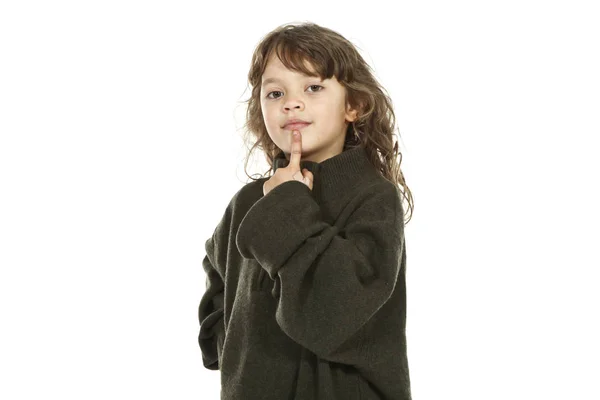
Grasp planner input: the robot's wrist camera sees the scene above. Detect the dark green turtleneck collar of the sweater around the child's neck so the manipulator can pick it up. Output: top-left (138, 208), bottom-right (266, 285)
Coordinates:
top-left (273, 146), bottom-right (378, 203)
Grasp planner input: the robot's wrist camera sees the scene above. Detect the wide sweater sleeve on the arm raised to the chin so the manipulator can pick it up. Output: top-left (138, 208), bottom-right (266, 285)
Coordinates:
top-left (236, 181), bottom-right (404, 363)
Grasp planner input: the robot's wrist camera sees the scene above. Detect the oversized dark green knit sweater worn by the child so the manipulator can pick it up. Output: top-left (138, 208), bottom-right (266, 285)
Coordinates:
top-left (198, 147), bottom-right (411, 400)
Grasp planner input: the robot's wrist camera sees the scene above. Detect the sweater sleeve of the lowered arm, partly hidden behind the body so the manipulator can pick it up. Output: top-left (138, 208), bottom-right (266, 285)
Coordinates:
top-left (198, 234), bottom-right (225, 370)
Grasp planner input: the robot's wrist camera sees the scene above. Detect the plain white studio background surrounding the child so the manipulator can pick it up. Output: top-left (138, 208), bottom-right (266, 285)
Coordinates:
top-left (0, 0), bottom-right (600, 400)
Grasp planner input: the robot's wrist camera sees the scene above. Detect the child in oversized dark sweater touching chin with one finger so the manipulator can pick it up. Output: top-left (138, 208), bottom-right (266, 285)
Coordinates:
top-left (198, 23), bottom-right (412, 400)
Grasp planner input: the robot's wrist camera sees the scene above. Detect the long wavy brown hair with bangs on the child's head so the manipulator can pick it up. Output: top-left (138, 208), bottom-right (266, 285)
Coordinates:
top-left (238, 22), bottom-right (414, 223)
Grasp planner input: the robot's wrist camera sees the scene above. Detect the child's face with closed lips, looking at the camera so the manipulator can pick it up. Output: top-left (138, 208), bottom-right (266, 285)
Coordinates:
top-left (260, 54), bottom-right (356, 162)
